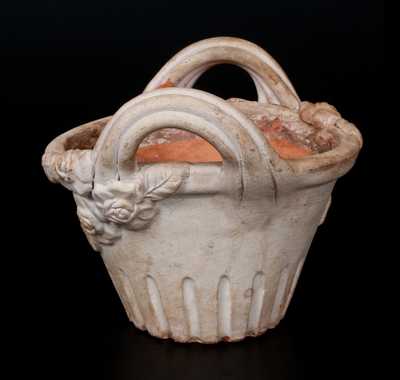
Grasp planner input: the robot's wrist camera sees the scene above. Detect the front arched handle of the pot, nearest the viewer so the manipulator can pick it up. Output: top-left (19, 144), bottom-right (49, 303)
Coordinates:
top-left (95, 88), bottom-right (285, 198)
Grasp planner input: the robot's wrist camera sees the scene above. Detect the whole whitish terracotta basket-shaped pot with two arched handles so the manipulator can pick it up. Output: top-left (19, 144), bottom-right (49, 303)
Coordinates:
top-left (43, 38), bottom-right (362, 343)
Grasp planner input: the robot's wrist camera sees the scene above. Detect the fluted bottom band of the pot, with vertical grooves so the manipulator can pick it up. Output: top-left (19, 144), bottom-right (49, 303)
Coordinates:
top-left (103, 257), bottom-right (304, 343)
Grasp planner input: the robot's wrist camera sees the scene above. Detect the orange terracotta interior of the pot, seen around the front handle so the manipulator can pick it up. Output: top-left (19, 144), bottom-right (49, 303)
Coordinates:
top-left (65, 99), bottom-right (337, 163)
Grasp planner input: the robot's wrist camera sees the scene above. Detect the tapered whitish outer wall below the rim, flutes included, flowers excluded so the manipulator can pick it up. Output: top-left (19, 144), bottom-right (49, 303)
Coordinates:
top-left (98, 189), bottom-right (329, 343)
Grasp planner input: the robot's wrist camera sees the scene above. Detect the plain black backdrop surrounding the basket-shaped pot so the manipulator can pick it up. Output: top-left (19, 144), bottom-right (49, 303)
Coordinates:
top-left (0, 0), bottom-right (385, 380)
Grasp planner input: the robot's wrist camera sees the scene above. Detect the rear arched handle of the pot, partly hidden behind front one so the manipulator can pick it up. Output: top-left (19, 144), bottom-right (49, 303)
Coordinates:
top-left (145, 37), bottom-right (300, 111)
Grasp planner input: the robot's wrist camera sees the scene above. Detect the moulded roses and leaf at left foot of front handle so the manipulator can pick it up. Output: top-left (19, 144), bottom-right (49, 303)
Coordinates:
top-left (60, 164), bottom-right (188, 251)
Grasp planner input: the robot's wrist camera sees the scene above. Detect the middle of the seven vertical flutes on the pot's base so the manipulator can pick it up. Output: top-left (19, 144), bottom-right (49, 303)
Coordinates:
top-left (218, 276), bottom-right (232, 340)
